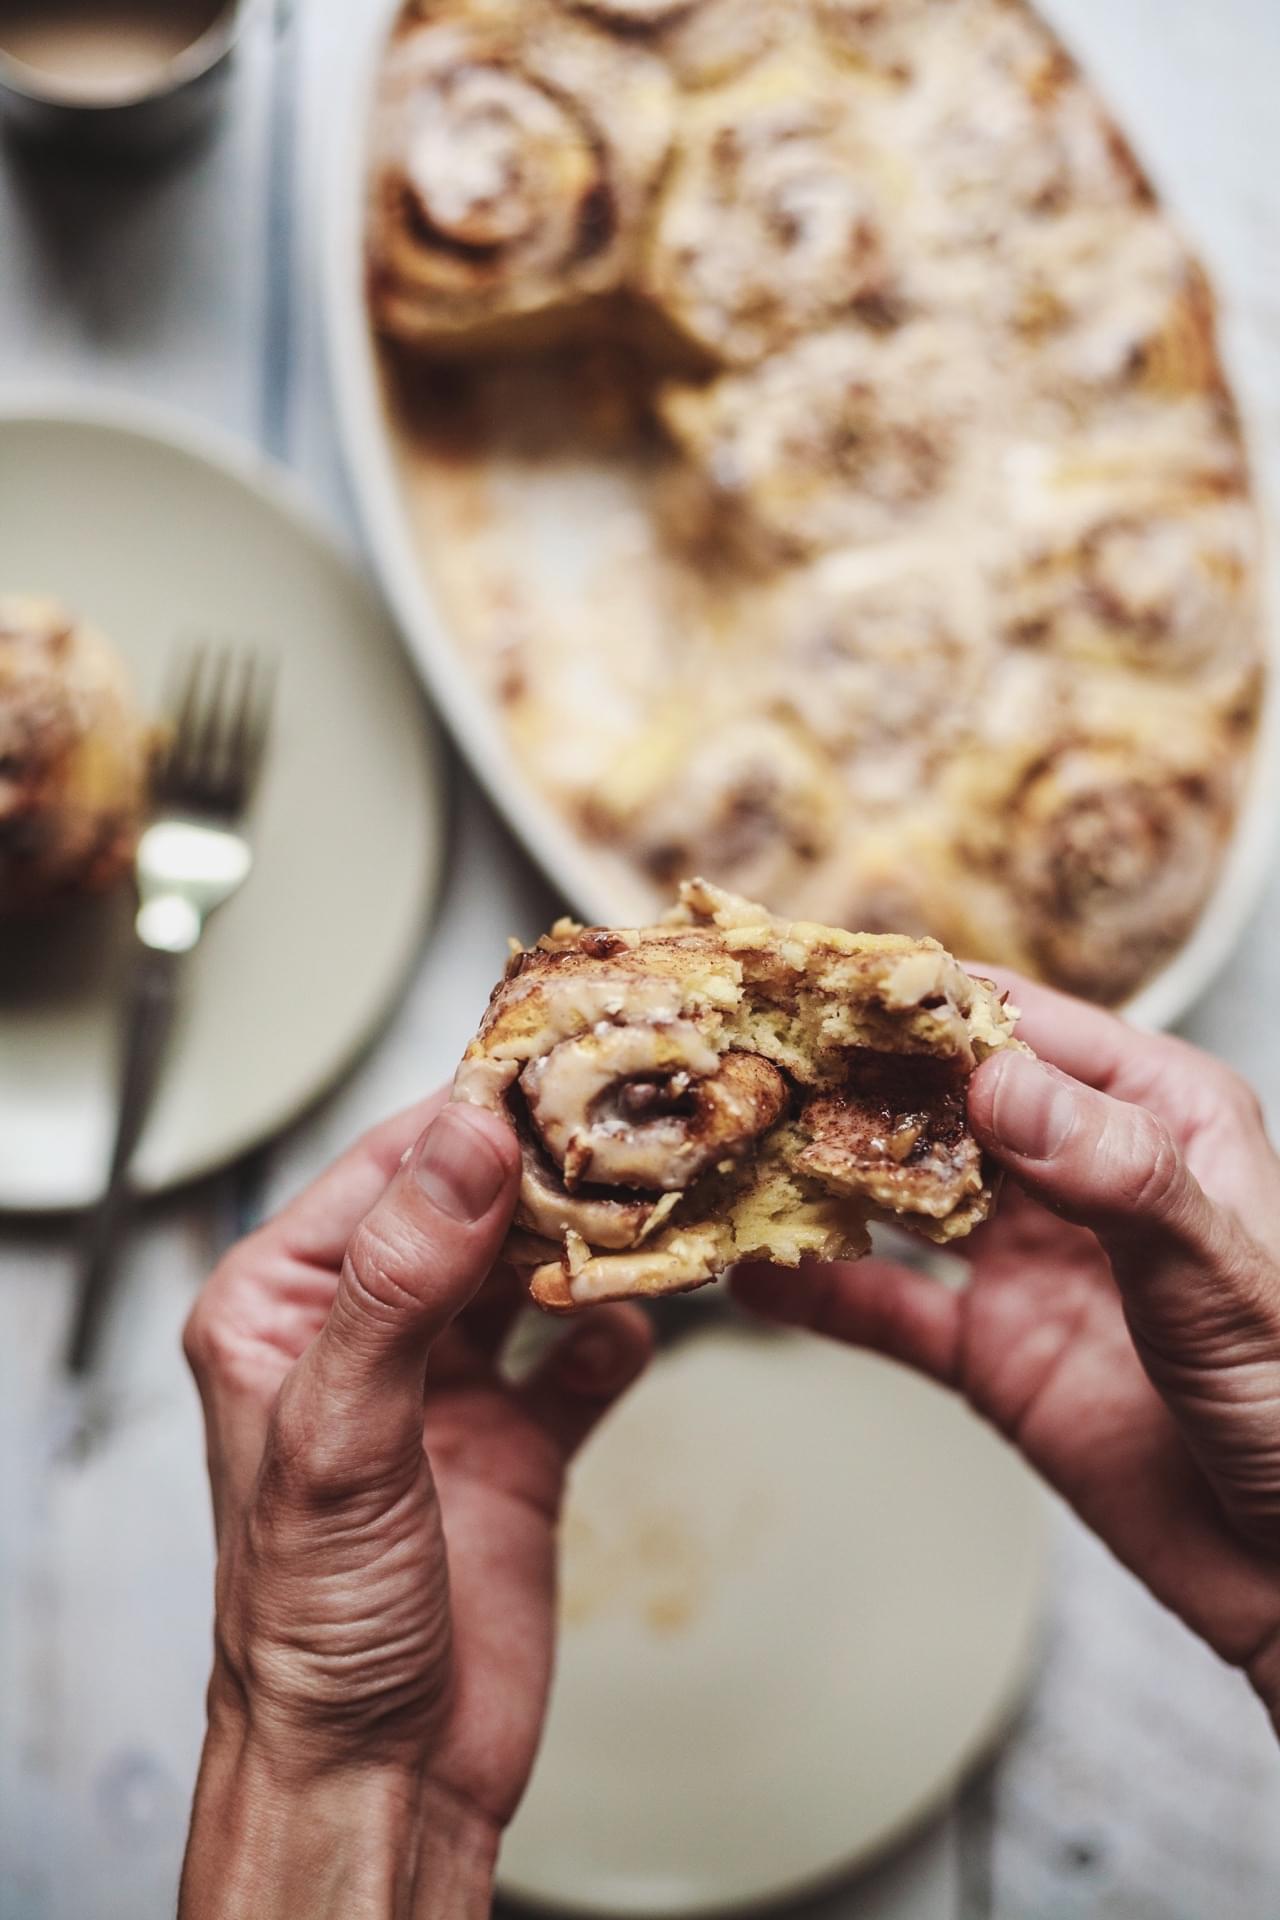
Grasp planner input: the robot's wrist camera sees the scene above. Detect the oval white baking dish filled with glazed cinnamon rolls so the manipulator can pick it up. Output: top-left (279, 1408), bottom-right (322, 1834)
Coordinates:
top-left (330, 0), bottom-right (1272, 1021)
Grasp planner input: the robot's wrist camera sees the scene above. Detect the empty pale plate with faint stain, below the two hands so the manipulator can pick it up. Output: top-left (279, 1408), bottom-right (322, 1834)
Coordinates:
top-left (501, 1332), bottom-right (1044, 1920)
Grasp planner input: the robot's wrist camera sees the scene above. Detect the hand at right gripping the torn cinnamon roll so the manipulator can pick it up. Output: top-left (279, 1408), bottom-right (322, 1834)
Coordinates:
top-left (735, 979), bottom-right (1280, 1730)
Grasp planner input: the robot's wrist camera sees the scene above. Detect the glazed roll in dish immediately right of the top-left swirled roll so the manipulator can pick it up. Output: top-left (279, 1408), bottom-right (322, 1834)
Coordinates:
top-left (637, 52), bottom-right (892, 365)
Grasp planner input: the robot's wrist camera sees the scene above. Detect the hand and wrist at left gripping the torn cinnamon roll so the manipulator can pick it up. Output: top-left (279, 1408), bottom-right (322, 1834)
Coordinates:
top-left (180, 1100), bottom-right (649, 1920)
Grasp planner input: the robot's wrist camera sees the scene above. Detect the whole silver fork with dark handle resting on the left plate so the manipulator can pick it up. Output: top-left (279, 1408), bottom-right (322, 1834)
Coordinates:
top-left (67, 645), bottom-right (274, 1375)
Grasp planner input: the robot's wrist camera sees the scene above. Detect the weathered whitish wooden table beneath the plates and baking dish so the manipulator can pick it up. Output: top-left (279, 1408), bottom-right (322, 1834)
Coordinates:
top-left (0, 0), bottom-right (1280, 1920)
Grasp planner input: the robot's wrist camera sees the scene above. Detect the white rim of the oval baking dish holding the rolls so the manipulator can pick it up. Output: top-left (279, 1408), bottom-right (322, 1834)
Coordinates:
top-left (322, 0), bottom-right (1280, 1027)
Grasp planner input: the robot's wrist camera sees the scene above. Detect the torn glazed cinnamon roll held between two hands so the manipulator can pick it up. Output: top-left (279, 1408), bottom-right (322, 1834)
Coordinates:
top-left (455, 881), bottom-right (1019, 1311)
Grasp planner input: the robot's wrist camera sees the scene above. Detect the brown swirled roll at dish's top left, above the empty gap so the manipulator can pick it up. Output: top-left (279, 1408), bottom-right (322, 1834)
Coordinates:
top-left (368, 17), bottom-right (672, 349)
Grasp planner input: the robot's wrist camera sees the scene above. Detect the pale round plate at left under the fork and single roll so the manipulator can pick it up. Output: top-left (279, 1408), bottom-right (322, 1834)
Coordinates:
top-left (0, 396), bottom-right (441, 1210)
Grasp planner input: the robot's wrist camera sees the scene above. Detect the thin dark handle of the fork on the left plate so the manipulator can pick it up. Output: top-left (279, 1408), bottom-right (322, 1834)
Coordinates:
top-left (65, 947), bottom-right (182, 1375)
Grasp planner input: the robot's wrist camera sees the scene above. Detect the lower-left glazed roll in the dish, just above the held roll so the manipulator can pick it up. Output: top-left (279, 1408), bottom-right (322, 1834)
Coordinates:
top-left (587, 708), bottom-right (842, 897)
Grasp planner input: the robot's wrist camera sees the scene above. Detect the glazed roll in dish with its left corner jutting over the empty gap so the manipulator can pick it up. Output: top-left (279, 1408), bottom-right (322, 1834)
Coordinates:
top-left (658, 321), bottom-right (981, 561)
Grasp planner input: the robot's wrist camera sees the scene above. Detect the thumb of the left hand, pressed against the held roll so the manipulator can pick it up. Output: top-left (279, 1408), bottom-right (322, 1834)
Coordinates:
top-left (288, 1104), bottom-right (520, 1482)
